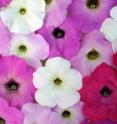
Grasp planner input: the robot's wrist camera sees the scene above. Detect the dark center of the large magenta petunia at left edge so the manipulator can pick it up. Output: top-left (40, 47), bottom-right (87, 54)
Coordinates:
top-left (6, 79), bottom-right (19, 92)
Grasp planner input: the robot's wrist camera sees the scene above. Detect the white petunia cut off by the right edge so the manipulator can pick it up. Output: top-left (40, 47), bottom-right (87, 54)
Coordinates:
top-left (100, 6), bottom-right (117, 52)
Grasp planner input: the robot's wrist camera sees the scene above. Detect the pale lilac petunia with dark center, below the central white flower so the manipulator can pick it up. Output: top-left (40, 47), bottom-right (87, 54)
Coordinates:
top-left (49, 102), bottom-right (84, 124)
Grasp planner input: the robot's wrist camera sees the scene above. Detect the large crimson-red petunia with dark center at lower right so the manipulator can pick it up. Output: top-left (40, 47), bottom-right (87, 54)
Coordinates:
top-left (80, 63), bottom-right (117, 121)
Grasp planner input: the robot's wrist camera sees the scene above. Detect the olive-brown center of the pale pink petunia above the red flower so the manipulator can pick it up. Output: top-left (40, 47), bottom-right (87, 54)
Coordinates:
top-left (87, 49), bottom-right (100, 60)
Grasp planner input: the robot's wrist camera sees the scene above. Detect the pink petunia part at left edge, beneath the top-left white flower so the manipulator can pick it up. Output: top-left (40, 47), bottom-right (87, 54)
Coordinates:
top-left (0, 19), bottom-right (11, 55)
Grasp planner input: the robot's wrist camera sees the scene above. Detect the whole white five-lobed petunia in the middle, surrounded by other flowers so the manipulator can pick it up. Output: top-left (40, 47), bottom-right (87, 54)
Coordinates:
top-left (33, 57), bottom-right (82, 108)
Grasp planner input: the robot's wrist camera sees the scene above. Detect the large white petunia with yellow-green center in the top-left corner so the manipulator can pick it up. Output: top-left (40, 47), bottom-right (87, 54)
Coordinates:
top-left (0, 0), bottom-right (45, 34)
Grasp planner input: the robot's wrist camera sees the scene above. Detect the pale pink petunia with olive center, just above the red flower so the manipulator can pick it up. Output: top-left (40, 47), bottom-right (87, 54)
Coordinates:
top-left (71, 30), bottom-right (113, 76)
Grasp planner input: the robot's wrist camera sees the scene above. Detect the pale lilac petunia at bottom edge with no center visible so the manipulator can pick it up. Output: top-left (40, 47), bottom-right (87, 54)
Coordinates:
top-left (22, 103), bottom-right (52, 124)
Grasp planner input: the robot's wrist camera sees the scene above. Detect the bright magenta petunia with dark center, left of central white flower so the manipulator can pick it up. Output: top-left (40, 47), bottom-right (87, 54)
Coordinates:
top-left (0, 56), bottom-right (35, 108)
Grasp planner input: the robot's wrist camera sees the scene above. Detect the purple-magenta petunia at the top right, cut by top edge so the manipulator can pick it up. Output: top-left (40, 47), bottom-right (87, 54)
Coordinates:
top-left (69, 0), bottom-right (115, 33)
